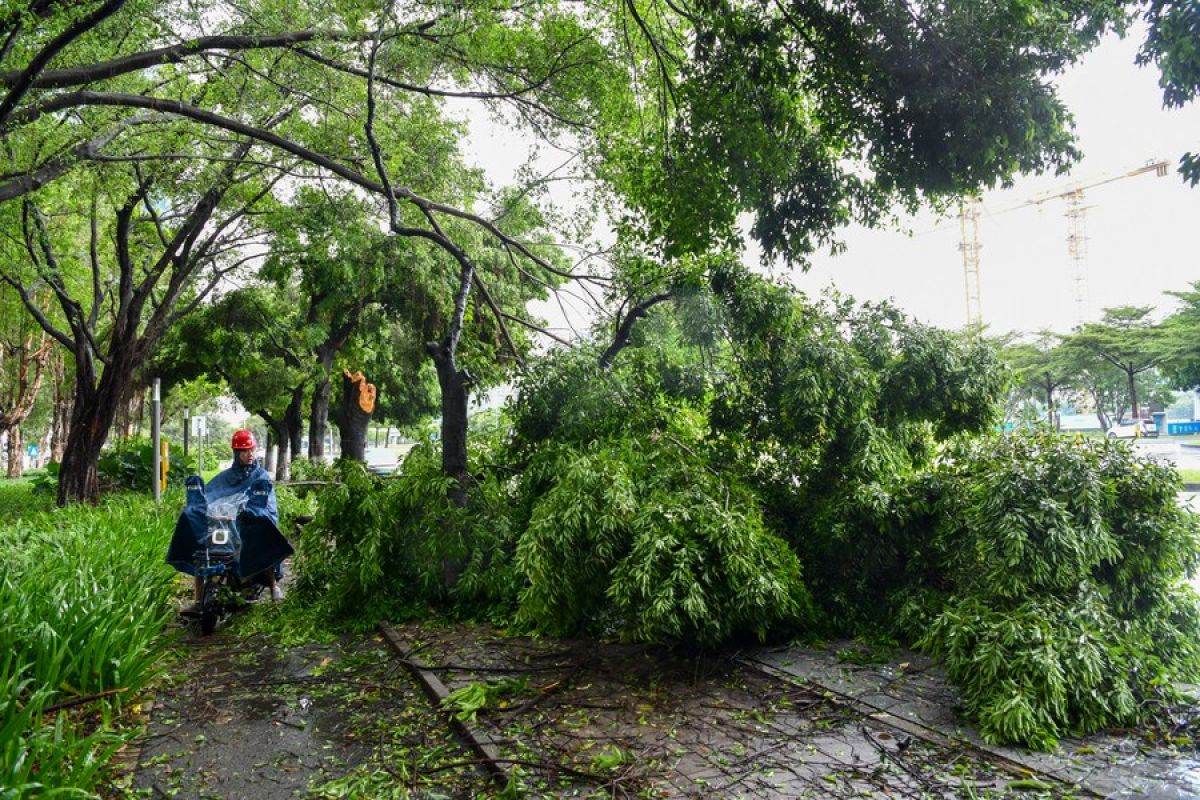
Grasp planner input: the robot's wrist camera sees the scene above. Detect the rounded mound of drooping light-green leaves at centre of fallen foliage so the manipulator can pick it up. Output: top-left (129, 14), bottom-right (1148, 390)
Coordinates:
top-left (516, 414), bottom-right (811, 645)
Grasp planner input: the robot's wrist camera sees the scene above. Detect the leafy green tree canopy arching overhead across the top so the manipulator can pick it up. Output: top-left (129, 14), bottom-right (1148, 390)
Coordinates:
top-left (0, 0), bottom-right (1194, 500)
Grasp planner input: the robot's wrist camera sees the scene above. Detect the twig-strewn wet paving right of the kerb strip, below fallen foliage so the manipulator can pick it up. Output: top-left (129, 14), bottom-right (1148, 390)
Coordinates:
top-left (384, 627), bottom-right (1161, 799)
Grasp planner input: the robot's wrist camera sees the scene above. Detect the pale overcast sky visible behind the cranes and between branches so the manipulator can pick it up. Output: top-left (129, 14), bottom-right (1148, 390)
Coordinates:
top-left (456, 25), bottom-right (1200, 337)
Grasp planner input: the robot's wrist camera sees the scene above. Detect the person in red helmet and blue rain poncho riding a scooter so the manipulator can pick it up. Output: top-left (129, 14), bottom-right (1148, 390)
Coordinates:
top-left (167, 431), bottom-right (292, 613)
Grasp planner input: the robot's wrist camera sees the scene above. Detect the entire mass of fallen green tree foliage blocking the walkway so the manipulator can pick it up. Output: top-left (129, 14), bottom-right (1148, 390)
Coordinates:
top-left (288, 269), bottom-right (1200, 747)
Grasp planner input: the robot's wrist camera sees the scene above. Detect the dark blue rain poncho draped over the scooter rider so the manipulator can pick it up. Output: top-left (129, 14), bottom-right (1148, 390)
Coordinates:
top-left (167, 459), bottom-right (293, 577)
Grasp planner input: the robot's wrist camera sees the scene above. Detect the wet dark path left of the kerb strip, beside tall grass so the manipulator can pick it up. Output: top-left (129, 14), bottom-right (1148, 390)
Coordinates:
top-left (130, 632), bottom-right (486, 800)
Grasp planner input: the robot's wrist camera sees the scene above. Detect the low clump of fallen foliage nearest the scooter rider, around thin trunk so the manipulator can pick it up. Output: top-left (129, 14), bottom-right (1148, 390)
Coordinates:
top-left (295, 441), bottom-right (516, 625)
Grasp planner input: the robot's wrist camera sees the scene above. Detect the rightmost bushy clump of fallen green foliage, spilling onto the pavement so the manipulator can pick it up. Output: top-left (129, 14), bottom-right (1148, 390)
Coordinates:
top-left (908, 434), bottom-right (1200, 748)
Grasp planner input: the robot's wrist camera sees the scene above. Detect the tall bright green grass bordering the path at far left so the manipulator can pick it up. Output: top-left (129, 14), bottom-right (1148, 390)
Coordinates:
top-left (0, 485), bottom-right (179, 799)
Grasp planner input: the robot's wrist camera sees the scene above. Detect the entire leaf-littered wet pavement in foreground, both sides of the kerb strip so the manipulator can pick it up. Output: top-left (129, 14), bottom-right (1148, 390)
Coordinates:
top-left (133, 625), bottom-right (1200, 800)
